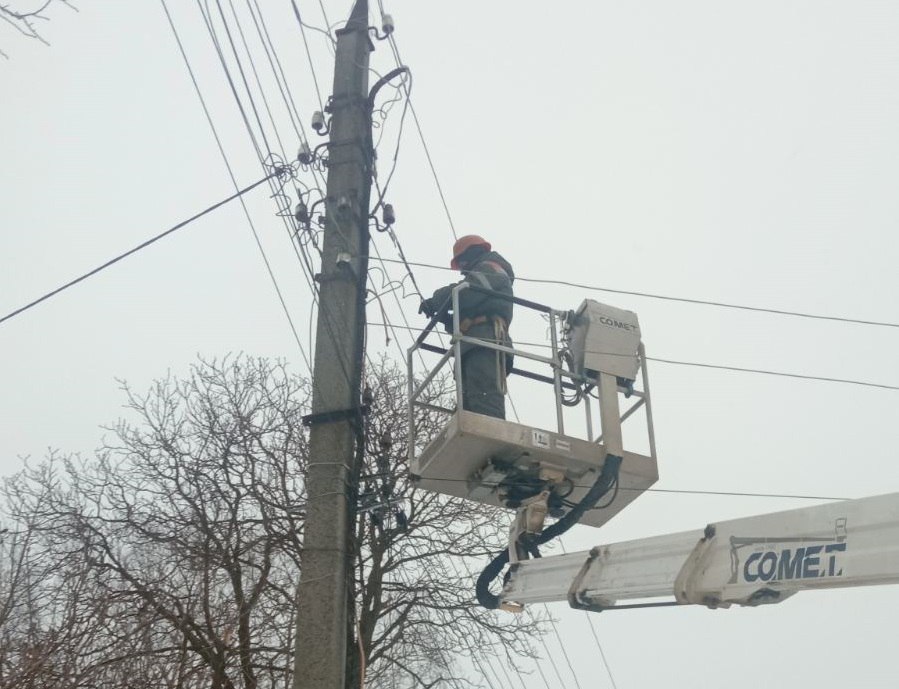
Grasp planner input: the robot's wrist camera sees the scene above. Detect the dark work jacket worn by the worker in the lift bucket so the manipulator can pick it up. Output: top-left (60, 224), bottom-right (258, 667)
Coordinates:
top-left (430, 251), bottom-right (515, 353)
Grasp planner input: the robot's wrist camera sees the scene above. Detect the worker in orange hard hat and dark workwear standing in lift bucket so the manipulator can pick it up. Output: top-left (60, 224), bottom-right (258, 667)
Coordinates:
top-left (418, 234), bottom-right (515, 419)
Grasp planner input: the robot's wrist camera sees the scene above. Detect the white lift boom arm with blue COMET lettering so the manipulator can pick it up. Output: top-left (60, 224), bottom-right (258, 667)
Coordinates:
top-left (500, 493), bottom-right (899, 611)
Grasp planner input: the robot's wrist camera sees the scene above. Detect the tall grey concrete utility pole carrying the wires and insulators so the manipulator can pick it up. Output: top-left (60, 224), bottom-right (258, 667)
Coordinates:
top-left (293, 0), bottom-right (373, 689)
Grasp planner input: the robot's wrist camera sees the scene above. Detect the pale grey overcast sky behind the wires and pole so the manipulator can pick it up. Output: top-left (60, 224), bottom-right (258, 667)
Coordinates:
top-left (0, 0), bottom-right (899, 689)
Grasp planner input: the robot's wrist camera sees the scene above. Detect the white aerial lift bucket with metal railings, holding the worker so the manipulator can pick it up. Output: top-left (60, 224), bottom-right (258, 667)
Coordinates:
top-left (407, 290), bottom-right (658, 528)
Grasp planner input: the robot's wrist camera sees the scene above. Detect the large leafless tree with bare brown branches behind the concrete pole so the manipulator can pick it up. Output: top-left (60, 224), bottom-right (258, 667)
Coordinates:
top-left (0, 356), bottom-right (542, 689)
